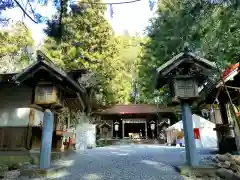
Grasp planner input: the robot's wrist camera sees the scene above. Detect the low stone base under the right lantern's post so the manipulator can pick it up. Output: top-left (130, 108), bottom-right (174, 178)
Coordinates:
top-left (175, 166), bottom-right (217, 177)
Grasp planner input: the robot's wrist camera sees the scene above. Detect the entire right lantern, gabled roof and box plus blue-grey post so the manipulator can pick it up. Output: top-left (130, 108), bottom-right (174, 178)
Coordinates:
top-left (156, 52), bottom-right (215, 166)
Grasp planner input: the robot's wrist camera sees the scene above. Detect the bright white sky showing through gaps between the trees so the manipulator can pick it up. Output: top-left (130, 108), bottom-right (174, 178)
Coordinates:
top-left (4, 0), bottom-right (153, 44)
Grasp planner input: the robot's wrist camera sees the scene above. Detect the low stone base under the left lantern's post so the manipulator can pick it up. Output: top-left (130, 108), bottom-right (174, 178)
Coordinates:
top-left (20, 166), bottom-right (67, 178)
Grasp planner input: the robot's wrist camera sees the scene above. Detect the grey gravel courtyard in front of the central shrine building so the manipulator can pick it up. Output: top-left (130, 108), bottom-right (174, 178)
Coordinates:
top-left (7, 145), bottom-right (217, 180)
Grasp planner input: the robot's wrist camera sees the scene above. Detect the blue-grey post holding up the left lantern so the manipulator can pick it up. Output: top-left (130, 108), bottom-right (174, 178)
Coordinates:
top-left (40, 109), bottom-right (53, 169)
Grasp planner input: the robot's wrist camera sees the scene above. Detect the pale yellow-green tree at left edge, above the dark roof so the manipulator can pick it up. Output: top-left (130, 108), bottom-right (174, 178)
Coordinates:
top-left (0, 22), bottom-right (33, 73)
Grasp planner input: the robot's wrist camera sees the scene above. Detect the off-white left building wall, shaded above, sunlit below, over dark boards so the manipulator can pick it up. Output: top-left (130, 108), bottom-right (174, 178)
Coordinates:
top-left (0, 86), bottom-right (32, 127)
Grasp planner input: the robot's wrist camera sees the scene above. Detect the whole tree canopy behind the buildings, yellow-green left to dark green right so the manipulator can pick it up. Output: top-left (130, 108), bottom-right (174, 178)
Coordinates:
top-left (0, 0), bottom-right (240, 104)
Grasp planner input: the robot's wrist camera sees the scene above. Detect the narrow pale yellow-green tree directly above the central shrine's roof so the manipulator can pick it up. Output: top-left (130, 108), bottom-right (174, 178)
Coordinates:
top-left (113, 32), bottom-right (142, 103)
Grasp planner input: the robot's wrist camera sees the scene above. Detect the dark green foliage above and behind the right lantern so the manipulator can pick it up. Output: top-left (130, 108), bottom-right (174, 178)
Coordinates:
top-left (139, 0), bottom-right (240, 102)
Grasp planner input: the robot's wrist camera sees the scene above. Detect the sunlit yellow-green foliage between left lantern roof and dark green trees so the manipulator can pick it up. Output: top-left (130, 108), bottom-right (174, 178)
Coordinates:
top-left (42, 1), bottom-right (140, 104)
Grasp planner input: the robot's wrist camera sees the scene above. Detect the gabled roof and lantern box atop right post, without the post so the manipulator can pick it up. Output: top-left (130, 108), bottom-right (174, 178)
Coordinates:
top-left (156, 52), bottom-right (215, 103)
